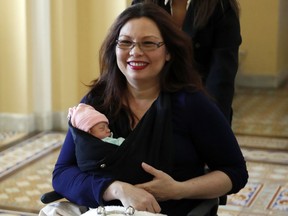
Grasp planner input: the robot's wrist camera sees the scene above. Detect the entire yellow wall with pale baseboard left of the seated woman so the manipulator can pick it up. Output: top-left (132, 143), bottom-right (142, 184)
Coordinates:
top-left (0, 0), bottom-right (127, 131)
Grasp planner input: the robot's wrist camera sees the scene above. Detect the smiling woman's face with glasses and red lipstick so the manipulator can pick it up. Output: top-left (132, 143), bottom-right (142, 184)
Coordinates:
top-left (116, 17), bottom-right (170, 86)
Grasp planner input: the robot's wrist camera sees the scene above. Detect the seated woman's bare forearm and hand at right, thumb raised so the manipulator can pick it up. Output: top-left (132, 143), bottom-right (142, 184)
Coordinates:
top-left (135, 163), bottom-right (232, 201)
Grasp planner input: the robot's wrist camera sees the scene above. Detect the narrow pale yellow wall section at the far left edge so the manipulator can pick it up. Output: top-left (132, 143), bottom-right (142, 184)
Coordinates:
top-left (0, 0), bottom-right (32, 113)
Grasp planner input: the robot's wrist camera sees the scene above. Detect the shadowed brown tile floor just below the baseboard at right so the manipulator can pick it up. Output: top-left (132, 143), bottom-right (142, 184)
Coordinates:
top-left (232, 82), bottom-right (288, 138)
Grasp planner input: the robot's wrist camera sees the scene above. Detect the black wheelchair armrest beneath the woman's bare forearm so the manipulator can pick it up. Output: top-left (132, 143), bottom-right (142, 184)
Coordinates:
top-left (187, 198), bottom-right (219, 216)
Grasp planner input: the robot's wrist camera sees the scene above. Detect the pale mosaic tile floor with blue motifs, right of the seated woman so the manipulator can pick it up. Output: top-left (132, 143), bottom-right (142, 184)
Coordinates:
top-left (219, 152), bottom-right (288, 216)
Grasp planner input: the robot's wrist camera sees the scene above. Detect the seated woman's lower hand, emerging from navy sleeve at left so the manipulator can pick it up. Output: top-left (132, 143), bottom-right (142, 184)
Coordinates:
top-left (103, 181), bottom-right (161, 213)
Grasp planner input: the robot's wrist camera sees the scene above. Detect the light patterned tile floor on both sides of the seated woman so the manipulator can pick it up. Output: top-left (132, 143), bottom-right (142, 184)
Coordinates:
top-left (0, 133), bottom-right (288, 216)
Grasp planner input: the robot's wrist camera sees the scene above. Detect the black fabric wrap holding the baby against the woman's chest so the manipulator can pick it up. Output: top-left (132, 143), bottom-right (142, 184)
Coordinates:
top-left (69, 93), bottom-right (174, 184)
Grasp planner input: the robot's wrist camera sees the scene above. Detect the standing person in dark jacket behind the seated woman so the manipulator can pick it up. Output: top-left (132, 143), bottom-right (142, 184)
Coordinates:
top-left (132, 0), bottom-right (242, 124)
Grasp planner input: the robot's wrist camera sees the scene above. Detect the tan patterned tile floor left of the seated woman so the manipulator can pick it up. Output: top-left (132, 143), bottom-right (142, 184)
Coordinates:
top-left (0, 132), bottom-right (65, 216)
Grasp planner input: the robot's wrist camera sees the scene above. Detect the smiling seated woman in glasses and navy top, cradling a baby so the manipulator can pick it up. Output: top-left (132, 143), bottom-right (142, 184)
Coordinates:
top-left (53, 4), bottom-right (248, 216)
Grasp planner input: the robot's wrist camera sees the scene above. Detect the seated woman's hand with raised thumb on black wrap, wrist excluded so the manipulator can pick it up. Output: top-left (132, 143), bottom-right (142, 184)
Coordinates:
top-left (135, 162), bottom-right (179, 201)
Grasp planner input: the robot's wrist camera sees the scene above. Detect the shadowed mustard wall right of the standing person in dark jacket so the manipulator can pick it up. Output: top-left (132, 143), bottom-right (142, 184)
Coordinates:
top-left (238, 0), bottom-right (288, 87)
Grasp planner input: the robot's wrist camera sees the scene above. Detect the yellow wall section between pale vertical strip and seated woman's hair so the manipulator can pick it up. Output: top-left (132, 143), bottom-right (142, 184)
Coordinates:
top-left (51, 0), bottom-right (126, 111)
